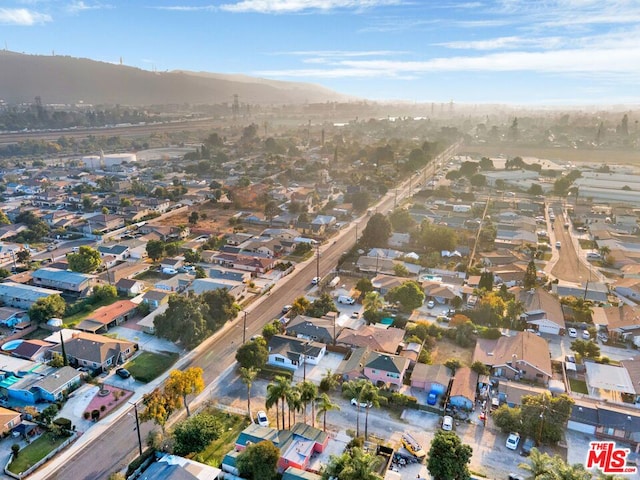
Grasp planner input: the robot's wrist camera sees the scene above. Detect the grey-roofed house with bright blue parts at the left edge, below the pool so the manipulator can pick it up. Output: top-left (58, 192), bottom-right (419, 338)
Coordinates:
top-left (7, 366), bottom-right (82, 403)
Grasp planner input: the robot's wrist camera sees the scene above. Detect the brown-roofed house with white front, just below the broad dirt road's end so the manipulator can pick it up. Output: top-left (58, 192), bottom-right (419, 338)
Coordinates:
top-left (511, 287), bottom-right (565, 335)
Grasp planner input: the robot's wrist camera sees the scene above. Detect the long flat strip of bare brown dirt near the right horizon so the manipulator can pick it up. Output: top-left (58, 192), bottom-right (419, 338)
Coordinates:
top-left (464, 145), bottom-right (638, 165)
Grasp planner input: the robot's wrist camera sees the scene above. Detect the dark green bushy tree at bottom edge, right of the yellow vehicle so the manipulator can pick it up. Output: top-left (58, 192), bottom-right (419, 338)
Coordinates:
top-left (427, 430), bottom-right (473, 480)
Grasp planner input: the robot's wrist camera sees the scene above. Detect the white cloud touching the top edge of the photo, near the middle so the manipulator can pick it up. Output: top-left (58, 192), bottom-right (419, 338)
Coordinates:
top-left (220, 0), bottom-right (405, 13)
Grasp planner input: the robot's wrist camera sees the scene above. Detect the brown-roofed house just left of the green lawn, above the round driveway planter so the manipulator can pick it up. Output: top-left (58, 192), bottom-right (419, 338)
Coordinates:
top-left (51, 332), bottom-right (138, 372)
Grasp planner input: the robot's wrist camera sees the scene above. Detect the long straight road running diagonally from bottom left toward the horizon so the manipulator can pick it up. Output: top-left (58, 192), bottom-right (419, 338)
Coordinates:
top-left (46, 145), bottom-right (458, 480)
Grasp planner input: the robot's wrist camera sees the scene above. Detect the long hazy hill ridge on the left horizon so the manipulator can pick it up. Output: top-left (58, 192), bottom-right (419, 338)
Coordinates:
top-left (0, 51), bottom-right (347, 105)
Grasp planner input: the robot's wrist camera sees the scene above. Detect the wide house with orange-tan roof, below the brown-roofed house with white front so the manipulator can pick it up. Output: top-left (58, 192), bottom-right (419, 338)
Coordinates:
top-left (473, 332), bottom-right (552, 385)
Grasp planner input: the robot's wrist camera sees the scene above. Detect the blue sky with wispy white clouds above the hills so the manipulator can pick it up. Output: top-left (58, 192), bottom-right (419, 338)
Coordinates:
top-left (0, 0), bottom-right (640, 105)
